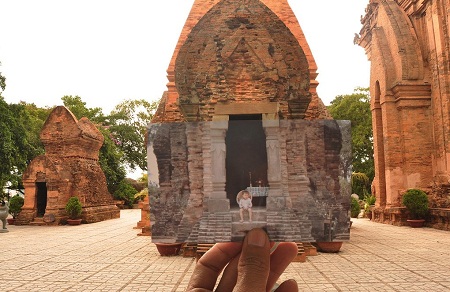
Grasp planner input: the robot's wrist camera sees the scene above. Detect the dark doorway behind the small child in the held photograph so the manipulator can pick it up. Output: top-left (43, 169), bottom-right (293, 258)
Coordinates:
top-left (225, 115), bottom-right (267, 207)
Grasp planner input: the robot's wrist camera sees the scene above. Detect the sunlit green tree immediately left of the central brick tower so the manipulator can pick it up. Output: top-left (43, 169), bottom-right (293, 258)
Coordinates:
top-left (108, 99), bottom-right (158, 170)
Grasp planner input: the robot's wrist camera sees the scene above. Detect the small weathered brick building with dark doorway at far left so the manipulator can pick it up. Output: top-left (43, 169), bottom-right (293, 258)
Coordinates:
top-left (17, 106), bottom-right (120, 224)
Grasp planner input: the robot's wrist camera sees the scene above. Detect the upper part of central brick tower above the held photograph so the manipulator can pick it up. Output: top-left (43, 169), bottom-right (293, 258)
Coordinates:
top-left (153, 0), bottom-right (331, 122)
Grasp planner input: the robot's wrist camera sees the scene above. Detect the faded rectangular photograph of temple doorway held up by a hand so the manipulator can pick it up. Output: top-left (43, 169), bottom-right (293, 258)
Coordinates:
top-left (147, 115), bottom-right (351, 243)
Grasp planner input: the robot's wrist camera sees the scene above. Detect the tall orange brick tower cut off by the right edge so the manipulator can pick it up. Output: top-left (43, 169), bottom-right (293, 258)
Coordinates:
top-left (357, 0), bottom-right (450, 230)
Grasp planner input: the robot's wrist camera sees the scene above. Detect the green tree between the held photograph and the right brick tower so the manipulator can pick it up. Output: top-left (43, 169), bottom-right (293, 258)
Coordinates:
top-left (327, 88), bottom-right (375, 181)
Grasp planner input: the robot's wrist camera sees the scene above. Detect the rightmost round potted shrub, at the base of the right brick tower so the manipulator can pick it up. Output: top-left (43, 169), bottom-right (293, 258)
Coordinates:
top-left (402, 189), bottom-right (429, 227)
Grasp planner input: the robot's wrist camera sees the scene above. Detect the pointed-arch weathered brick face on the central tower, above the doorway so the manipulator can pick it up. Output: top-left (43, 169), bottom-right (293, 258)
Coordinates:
top-left (175, 1), bottom-right (311, 120)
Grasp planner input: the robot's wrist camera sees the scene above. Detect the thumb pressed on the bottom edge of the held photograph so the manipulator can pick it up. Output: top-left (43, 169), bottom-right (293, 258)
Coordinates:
top-left (233, 228), bottom-right (270, 292)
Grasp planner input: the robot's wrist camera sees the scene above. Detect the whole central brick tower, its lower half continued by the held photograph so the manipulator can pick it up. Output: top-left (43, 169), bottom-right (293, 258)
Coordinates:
top-left (147, 0), bottom-right (350, 242)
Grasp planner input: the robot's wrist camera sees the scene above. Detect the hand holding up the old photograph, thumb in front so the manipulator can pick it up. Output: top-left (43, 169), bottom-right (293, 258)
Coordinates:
top-left (186, 228), bottom-right (298, 292)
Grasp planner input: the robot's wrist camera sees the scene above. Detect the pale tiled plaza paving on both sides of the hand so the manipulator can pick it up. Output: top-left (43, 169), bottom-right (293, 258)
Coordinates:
top-left (0, 210), bottom-right (450, 291)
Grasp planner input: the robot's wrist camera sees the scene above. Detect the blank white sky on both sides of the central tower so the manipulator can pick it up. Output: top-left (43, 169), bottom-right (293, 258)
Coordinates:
top-left (0, 0), bottom-right (369, 114)
